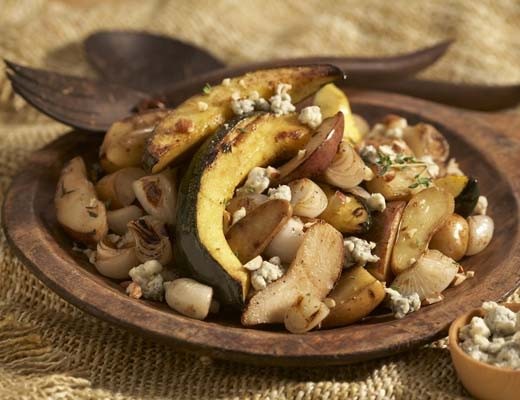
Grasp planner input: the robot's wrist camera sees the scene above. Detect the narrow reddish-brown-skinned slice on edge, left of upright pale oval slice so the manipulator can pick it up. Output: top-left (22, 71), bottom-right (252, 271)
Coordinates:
top-left (364, 201), bottom-right (406, 282)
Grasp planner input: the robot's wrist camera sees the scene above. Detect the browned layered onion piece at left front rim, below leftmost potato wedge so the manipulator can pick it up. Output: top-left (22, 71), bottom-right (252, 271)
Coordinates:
top-left (94, 237), bottom-right (140, 279)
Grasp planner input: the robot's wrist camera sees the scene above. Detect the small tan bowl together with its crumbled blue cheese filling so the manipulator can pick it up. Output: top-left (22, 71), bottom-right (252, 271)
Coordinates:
top-left (449, 302), bottom-right (520, 400)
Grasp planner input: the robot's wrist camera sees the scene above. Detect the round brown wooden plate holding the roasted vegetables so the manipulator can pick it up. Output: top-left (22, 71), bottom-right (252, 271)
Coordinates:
top-left (3, 92), bottom-right (520, 366)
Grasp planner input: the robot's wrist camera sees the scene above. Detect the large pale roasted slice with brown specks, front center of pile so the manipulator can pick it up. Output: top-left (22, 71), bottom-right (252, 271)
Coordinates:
top-left (242, 222), bottom-right (343, 326)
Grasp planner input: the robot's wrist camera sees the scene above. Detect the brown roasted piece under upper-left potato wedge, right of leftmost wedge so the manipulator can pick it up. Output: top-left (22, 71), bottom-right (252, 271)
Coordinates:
top-left (96, 167), bottom-right (145, 210)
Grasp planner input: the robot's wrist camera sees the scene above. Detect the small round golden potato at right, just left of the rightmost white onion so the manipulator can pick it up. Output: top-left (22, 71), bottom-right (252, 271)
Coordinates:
top-left (429, 214), bottom-right (469, 261)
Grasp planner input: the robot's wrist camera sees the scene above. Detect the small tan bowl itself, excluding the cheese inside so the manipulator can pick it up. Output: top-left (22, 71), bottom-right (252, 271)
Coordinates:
top-left (449, 303), bottom-right (520, 400)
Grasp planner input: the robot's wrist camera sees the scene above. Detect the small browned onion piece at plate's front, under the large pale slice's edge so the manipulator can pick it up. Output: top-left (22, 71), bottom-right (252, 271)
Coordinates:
top-left (284, 293), bottom-right (330, 333)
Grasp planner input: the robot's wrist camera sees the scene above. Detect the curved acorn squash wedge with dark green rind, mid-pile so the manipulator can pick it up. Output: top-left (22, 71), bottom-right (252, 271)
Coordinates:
top-left (176, 113), bottom-right (311, 307)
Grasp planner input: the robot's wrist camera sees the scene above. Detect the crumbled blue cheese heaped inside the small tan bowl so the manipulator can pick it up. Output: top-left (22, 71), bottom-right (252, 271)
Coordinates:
top-left (459, 301), bottom-right (520, 369)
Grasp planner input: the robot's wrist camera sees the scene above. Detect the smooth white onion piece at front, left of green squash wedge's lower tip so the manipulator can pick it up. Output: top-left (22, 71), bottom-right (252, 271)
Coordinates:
top-left (164, 278), bottom-right (213, 319)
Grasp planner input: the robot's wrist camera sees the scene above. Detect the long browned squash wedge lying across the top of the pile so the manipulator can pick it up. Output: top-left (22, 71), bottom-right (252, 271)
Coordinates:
top-left (143, 64), bottom-right (343, 173)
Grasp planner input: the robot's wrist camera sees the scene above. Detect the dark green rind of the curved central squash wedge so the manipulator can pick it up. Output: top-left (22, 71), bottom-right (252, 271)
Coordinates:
top-left (174, 112), bottom-right (262, 309)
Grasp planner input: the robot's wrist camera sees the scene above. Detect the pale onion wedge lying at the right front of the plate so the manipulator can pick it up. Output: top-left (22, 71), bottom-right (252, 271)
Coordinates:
top-left (391, 250), bottom-right (459, 301)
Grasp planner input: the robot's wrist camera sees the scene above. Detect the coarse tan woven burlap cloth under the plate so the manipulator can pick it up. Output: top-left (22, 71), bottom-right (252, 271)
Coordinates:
top-left (0, 0), bottom-right (520, 399)
